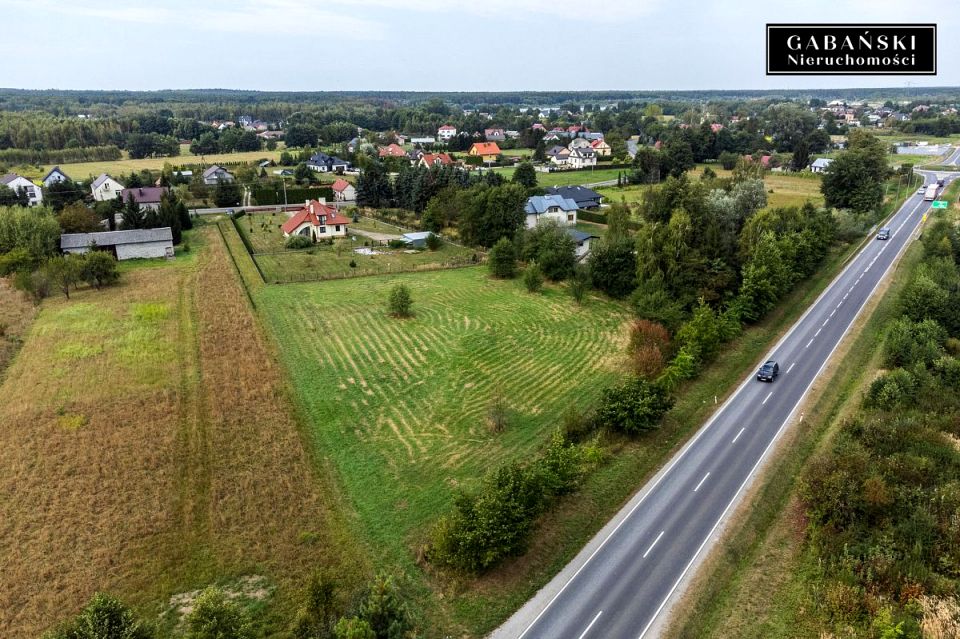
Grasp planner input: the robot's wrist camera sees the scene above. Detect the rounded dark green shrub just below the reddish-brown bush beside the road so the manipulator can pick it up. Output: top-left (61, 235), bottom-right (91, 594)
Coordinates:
top-left (597, 377), bottom-right (673, 435)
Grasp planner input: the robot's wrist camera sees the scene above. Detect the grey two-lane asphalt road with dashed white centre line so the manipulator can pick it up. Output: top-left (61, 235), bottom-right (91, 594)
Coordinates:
top-left (491, 158), bottom-right (960, 639)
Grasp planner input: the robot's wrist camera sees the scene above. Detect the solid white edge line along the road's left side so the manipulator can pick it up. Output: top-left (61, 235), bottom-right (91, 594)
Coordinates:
top-left (512, 182), bottom-right (924, 639)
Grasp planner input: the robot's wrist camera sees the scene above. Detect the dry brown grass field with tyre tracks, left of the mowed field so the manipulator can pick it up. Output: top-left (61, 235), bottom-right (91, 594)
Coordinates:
top-left (0, 230), bottom-right (365, 639)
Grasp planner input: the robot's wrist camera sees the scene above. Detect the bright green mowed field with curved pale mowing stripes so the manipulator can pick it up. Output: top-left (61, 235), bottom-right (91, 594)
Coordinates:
top-left (256, 268), bottom-right (628, 565)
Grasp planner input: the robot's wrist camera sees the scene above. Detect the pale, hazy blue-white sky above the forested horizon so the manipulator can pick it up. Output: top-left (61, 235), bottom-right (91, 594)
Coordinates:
top-left (0, 0), bottom-right (960, 91)
